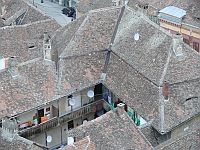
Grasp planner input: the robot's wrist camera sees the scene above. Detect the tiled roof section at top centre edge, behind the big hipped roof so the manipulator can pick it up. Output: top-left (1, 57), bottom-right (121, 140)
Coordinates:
top-left (77, 0), bottom-right (114, 14)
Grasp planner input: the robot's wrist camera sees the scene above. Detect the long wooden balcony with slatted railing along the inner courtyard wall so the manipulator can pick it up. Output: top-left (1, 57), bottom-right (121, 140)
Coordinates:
top-left (18, 99), bottom-right (105, 138)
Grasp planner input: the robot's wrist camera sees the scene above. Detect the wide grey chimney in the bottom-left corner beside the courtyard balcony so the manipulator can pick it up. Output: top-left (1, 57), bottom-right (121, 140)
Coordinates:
top-left (2, 117), bottom-right (18, 139)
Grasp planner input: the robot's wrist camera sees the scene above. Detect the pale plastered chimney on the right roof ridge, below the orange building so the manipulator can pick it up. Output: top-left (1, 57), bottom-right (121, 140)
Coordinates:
top-left (173, 33), bottom-right (183, 57)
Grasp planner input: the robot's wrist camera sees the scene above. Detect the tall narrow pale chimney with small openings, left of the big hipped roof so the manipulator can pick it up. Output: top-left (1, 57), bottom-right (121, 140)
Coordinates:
top-left (43, 32), bottom-right (52, 60)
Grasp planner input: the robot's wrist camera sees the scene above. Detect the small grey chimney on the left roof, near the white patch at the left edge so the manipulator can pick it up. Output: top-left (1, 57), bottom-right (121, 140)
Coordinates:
top-left (8, 56), bottom-right (18, 79)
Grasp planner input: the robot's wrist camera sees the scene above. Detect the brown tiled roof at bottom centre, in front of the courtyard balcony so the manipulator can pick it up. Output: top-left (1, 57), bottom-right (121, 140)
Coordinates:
top-left (68, 110), bottom-right (153, 150)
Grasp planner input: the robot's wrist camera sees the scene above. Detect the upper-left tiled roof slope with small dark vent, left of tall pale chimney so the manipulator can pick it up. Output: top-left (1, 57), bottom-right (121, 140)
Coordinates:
top-left (0, 19), bottom-right (60, 62)
